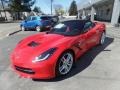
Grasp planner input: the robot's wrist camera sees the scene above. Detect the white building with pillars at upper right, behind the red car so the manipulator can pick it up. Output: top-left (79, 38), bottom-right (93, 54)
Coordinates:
top-left (78, 0), bottom-right (120, 25)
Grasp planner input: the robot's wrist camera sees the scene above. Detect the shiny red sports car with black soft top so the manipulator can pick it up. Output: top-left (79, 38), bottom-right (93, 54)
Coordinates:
top-left (11, 20), bottom-right (106, 79)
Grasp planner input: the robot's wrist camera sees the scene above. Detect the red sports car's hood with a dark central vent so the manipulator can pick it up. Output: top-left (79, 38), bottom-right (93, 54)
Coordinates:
top-left (13, 32), bottom-right (71, 60)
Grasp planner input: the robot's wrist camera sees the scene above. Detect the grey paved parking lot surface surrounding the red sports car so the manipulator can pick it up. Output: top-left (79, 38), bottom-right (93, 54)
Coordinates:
top-left (0, 23), bottom-right (120, 90)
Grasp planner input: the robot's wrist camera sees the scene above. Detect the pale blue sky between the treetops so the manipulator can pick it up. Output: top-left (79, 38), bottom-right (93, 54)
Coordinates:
top-left (34, 0), bottom-right (81, 14)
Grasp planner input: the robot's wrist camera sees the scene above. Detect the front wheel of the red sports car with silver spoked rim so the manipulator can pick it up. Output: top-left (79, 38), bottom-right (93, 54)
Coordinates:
top-left (56, 51), bottom-right (74, 77)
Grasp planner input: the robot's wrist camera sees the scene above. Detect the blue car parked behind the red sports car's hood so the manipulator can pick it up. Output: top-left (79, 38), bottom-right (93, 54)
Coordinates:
top-left (20, 16), bottom-right (53, 31)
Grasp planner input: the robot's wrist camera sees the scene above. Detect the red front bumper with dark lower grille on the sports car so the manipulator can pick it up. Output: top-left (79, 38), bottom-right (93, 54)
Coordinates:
top-left (12, 57), bottom-right (55, 79)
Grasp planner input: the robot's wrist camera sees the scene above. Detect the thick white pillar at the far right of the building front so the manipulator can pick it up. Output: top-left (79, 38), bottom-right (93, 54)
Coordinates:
top-left (111, 0), bottom-right (120, 26)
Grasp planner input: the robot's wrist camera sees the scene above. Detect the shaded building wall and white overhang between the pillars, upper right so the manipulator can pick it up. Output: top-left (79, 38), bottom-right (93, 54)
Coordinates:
top-left (78, 0), bottom-right (120, 22)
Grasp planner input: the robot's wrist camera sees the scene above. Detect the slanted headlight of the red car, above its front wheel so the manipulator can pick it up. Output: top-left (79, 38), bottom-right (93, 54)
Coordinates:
top-left (32, 48), bottom-right (57, 63)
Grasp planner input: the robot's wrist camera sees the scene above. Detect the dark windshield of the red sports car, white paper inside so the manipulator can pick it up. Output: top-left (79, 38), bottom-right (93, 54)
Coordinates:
top-left (50, 20), bottom-right (84, 36)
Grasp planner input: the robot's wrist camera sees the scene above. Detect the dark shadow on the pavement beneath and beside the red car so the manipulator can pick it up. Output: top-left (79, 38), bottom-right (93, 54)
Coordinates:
top-left (34, 37), bottom-right (114, 82)
